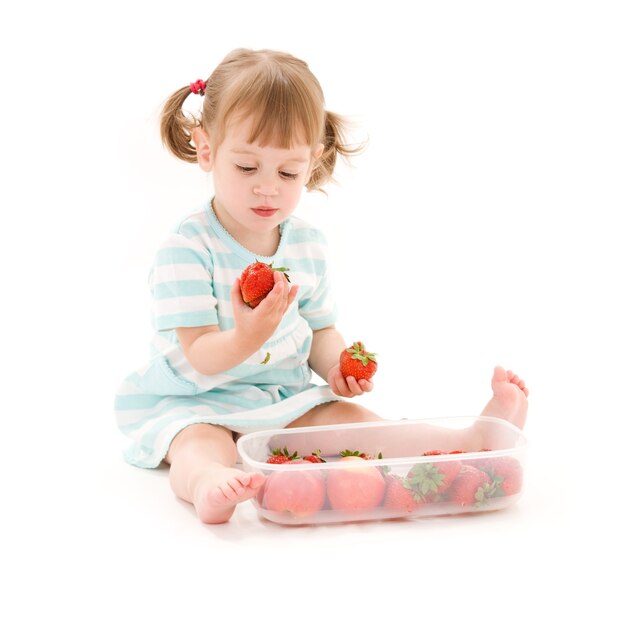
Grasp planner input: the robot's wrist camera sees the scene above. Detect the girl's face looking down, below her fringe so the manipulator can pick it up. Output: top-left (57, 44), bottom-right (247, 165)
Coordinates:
top-left (198, 120), bottom-right (323, 255)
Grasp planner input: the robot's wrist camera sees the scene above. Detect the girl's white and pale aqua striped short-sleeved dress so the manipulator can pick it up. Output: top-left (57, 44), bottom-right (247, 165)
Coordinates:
top-left (115, 203), bottom-right (340, 468)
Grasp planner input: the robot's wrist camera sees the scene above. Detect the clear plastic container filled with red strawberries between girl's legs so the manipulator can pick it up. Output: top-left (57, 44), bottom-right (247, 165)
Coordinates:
top-left (237, 417), bottom-right (527, 525)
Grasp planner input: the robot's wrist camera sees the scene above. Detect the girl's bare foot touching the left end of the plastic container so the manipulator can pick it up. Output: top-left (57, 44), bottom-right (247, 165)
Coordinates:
top-left (193, 466), bottom-right (265, 524)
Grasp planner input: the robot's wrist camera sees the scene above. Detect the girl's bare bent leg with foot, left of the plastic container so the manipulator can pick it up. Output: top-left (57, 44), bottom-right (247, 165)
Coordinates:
top-left (165, 423), bottom-right (265, 523)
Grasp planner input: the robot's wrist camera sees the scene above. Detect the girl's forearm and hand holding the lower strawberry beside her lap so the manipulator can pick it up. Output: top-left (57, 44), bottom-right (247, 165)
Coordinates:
top-left (309, 326), bottom-right (374, 397)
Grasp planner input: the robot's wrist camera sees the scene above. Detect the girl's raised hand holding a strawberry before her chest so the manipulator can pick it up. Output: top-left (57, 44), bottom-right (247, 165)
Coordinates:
top-left (230, 272), bottom-right (298, 350)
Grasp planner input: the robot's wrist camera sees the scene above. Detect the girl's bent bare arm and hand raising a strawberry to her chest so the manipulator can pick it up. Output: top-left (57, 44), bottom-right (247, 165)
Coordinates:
top-left (176, 272), bottom-right (298, 376)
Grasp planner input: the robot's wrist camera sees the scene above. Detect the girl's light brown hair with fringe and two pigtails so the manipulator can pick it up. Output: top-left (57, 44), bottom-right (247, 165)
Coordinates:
top-left (161, 49), bottom-right (363, 190)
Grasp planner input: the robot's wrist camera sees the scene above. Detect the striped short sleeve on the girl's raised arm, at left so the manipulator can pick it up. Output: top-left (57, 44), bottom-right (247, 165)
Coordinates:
top-left (150, 234), bottom-right (218, 330)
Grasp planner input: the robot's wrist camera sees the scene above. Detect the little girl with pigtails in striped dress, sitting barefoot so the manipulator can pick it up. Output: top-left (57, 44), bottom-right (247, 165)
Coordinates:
top-left (115, 49), bottom-right (528, 523)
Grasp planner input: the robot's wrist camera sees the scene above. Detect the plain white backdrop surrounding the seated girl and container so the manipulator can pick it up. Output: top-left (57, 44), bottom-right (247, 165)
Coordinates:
top-left (0, 0), bottom-right (626, 620)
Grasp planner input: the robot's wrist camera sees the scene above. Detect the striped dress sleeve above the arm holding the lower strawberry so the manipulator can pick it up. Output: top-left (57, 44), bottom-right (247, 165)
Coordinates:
top-left (298, 225), bottom-right (337, 330)
